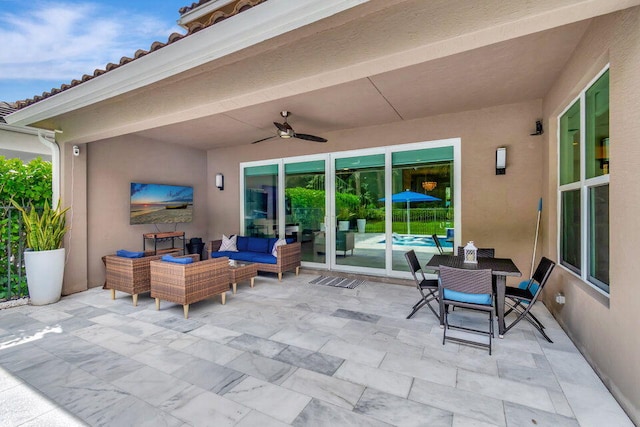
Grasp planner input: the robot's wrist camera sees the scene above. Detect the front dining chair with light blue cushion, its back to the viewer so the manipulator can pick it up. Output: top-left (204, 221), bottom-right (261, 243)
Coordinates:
top-left (438, 265), bottom-right (494, 355)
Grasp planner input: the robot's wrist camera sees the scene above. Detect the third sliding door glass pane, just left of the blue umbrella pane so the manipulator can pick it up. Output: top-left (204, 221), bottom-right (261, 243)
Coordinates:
top-left (334, 154), bottom-right (385, 269)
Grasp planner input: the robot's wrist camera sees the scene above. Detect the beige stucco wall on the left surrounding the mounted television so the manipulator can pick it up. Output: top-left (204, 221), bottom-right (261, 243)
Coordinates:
top-left (87, 136), bottom-right (208, 287)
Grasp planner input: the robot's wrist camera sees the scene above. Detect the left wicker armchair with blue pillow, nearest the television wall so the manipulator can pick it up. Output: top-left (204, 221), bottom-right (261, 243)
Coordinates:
top-left (102, 251), bottom-right (169, 306)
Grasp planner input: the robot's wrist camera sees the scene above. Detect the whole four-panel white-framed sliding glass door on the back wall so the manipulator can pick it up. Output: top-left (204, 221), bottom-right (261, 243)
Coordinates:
top-left (241, 139), bottom-right (460, 277)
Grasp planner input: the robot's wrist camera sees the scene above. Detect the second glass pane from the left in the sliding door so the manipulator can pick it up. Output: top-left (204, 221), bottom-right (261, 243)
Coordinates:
top-left (284, 160), bottom-right (326, 264)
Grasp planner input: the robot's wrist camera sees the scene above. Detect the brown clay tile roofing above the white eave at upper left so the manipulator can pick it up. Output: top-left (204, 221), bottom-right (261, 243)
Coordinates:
top-left (13, 0), bottom-right (268, 114)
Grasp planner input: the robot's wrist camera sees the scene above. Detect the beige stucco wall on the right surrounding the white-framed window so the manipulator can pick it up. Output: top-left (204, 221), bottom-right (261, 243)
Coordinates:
top-left (544, 8), bottom-right (640, 423)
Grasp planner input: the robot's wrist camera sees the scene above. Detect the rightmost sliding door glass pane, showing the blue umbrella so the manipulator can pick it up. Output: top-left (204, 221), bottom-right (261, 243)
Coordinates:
top-left (391, 146), bottom-right (454, 271)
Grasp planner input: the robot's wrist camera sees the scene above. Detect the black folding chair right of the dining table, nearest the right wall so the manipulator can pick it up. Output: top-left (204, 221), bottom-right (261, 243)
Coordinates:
top-left (504, 257), bottom-right (556, 343)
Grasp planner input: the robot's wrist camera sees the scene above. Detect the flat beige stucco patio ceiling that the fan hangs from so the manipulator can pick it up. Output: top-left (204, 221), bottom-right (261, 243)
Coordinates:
top-left (136, 21), bottom-right (588, 150)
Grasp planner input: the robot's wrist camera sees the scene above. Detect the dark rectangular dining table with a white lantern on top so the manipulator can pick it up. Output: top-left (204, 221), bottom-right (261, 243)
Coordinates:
top-left (425, 255), bottom-right (522, 338)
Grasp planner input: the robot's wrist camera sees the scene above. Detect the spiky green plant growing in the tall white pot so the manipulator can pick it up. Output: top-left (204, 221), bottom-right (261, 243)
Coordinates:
top-left (11, 200), bottom-right (69, 251)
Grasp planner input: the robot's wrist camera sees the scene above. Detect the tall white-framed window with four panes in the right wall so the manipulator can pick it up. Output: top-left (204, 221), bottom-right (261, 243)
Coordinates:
top-left (558, 67), bottom-right (610, 294)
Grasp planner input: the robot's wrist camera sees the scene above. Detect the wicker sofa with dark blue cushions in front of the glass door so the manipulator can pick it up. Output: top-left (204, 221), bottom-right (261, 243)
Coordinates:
top-left (209, 236), bottom-right (302, 281)
